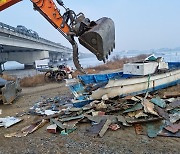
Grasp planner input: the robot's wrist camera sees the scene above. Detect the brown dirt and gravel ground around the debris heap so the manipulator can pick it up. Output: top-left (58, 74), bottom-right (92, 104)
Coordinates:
top-left (0, 83), bottom-right (180, 154)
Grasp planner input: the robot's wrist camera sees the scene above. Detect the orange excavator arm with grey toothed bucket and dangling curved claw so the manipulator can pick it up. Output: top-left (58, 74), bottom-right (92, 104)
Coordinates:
top-left (0, 0), bottom-right (115, 73)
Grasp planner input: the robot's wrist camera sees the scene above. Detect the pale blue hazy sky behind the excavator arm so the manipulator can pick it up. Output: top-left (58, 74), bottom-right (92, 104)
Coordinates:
top-left (0, 0), bottom-right (180, 51)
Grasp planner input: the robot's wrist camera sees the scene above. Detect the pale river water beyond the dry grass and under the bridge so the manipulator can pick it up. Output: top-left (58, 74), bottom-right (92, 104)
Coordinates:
top-left (4, 51), bottom-right (180, 78)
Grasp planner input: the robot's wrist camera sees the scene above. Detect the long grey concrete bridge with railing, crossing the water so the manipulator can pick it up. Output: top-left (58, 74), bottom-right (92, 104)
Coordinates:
top-left (0, 22), bottom-right (72, 73)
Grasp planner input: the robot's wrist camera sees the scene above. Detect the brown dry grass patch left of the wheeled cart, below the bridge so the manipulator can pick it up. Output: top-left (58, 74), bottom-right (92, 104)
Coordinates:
top-left (20, 74), bottom-right (46, 87)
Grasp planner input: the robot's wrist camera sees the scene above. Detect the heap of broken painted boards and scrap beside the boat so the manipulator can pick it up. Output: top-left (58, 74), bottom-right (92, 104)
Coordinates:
top-left (0, 93), bottom-right (180, 137)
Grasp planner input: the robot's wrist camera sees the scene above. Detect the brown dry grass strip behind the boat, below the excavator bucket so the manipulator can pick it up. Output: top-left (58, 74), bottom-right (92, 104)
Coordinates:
top-left (73, 54), bottom-right (148, 77)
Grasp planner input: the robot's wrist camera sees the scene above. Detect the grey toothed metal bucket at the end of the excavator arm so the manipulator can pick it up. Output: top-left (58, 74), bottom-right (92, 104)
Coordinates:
top-left (79, 17), bottom-right (115, 62)
